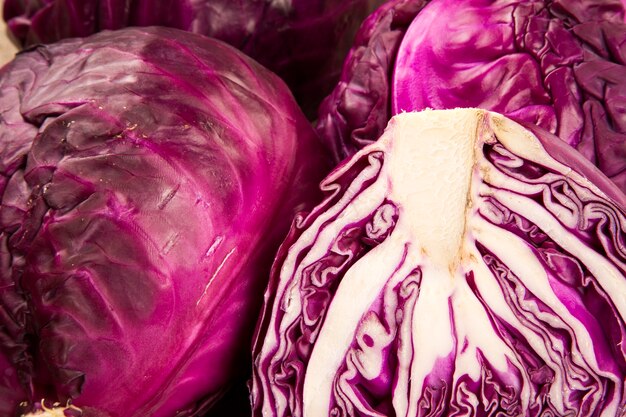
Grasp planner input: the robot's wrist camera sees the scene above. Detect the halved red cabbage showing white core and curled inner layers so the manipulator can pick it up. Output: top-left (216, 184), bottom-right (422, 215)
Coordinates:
top-left (252, 109), bottom-right (626, 417)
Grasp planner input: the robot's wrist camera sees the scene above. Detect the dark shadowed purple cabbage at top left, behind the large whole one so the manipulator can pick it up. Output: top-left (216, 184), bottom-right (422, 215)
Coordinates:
top-left (4, 0), bottom-right (382, 114)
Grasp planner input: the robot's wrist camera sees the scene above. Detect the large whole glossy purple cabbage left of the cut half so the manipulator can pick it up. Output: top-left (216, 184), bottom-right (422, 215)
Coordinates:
top-left (0, 28), bottom-right (327, 417)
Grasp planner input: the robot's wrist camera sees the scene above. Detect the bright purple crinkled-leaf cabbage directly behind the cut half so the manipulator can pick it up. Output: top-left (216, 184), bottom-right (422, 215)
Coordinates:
top-left (318, 0), bottom-right (626, 190)
